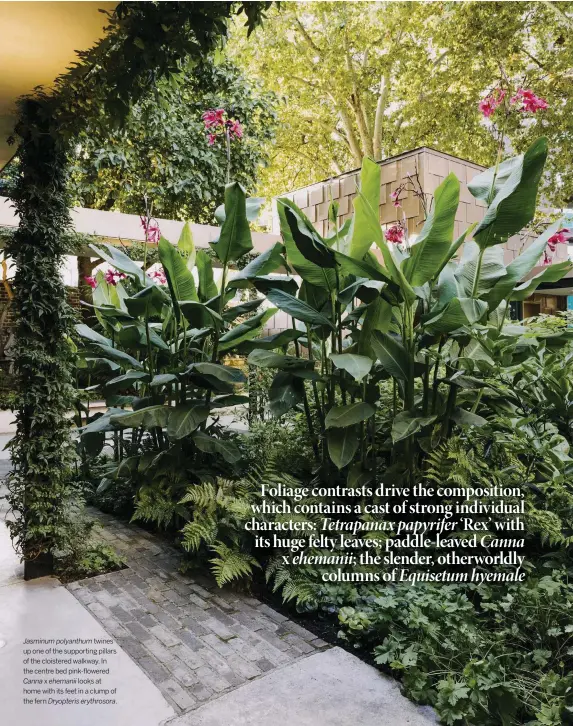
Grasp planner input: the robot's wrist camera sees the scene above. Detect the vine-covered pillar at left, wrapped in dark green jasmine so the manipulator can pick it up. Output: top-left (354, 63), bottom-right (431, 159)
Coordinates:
top-left (7, 94), bottom-right (73, 579)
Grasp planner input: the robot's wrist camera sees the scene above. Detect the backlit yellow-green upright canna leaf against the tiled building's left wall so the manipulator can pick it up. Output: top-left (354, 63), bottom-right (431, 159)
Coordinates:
top-left (348, 157), bottom-right (380, 260)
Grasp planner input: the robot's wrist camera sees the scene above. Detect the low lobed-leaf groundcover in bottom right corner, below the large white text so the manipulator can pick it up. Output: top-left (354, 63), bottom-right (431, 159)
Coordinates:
top-left (330, 566), bottom-right (573, 726)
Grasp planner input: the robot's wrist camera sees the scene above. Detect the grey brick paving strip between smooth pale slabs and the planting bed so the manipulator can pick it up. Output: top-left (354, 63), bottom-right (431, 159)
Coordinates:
top-left (67, 510), bottom-right (328, 713)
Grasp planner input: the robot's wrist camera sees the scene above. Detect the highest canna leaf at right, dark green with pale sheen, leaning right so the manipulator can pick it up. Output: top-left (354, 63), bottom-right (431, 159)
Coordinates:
top-left (474, 137), bottom-right (547, 248)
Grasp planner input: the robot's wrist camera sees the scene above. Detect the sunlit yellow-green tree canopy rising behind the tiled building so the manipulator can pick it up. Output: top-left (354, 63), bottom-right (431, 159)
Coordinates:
top-left (230, 2), bottom-right (573, 203)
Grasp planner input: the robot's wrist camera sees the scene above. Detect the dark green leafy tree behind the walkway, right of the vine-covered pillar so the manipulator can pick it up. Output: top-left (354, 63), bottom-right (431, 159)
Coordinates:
top-left (71, 57), bottom-right (275, 222)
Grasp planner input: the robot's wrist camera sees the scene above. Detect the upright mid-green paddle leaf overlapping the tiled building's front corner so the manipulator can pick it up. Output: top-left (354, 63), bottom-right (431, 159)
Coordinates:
top-left (403, 174), bottom-right (460, 287)
